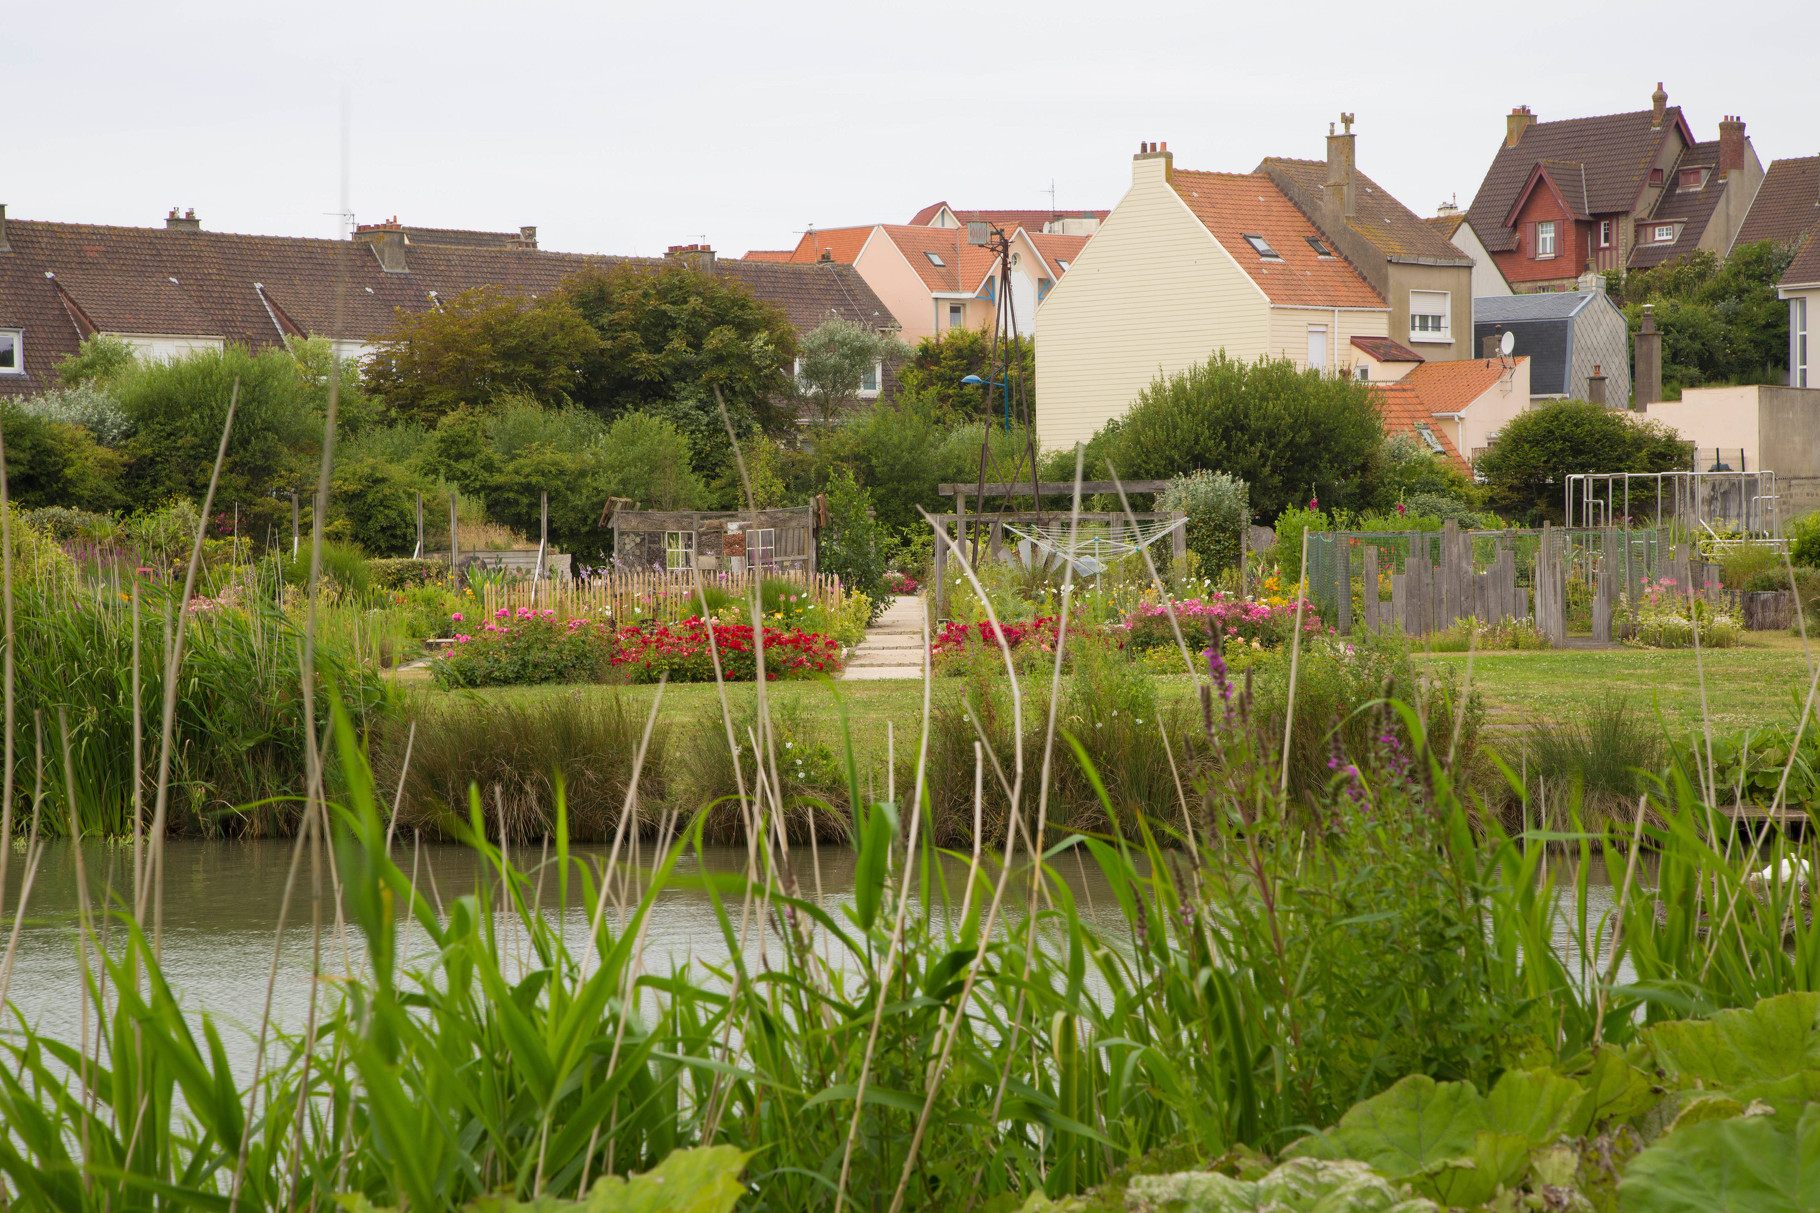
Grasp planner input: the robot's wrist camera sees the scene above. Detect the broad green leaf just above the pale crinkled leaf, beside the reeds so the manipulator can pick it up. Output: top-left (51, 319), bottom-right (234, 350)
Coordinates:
top-left (1285, 1075), bottom-right (1492, 1178)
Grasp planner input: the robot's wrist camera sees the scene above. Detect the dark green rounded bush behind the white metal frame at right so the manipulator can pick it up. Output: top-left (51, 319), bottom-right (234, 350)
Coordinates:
top-left (1478, 401), bottom-right (1687, 523)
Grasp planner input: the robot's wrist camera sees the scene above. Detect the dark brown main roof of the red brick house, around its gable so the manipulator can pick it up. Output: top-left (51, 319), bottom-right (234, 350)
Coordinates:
top-left (1467, 106), bottom-right (1693, 253)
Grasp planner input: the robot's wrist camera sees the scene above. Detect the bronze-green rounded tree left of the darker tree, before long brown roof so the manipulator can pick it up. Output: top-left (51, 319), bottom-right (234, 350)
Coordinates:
top-left (366, 286), bottom-right (601, 424)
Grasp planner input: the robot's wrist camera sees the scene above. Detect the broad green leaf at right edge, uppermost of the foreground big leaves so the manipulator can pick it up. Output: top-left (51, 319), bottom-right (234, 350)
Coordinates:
top-left (1643, 993), bottom-right (1820, 1087)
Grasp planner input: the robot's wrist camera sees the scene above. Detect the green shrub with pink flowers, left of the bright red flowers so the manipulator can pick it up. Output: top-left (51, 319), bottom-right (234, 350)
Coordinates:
top-left (430, 607), bottom-right (615, 687)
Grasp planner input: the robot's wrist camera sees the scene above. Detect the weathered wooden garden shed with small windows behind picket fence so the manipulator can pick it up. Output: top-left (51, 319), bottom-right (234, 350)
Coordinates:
top-left (610, 505), bottom-right (819, 574)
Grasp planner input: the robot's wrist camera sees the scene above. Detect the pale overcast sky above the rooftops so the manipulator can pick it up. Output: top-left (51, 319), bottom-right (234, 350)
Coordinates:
top-left (0, 0), bottom-right (1820, 257)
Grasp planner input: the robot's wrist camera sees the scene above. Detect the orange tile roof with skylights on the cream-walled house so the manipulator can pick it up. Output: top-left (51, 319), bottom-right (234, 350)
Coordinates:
top-left (1170, 169), bottom-right (1385, 308)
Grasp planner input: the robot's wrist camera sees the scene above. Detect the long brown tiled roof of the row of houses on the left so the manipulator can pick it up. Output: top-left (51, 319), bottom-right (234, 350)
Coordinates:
top-left (0, 219), bottom-right (895, 393)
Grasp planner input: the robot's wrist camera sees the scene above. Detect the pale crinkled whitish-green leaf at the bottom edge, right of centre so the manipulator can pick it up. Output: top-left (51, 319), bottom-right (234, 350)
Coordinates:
top-left (1125, 1158), bottom-right (1434, 1213)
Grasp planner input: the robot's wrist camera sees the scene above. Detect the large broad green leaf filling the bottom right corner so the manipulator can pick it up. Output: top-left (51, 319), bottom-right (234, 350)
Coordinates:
top-left (1618, 1104), bottom-right (1820, 1213)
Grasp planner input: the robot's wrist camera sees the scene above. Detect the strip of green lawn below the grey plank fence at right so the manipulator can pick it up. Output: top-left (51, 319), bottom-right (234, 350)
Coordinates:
top-left (1420, 634), bottom-right (1820, 730)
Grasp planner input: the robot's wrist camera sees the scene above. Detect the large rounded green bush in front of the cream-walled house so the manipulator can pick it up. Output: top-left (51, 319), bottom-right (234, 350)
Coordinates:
top-left (1088, 350), bottom-right (1383, 523)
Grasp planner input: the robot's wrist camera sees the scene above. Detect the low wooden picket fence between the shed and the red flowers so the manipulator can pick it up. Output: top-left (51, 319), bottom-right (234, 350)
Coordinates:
top-left (480, 570), bottom-right (846, 623)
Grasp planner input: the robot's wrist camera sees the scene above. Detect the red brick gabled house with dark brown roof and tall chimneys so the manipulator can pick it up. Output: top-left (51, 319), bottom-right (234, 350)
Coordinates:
top-left (1467, 84), bottom-right (1764, 293)
